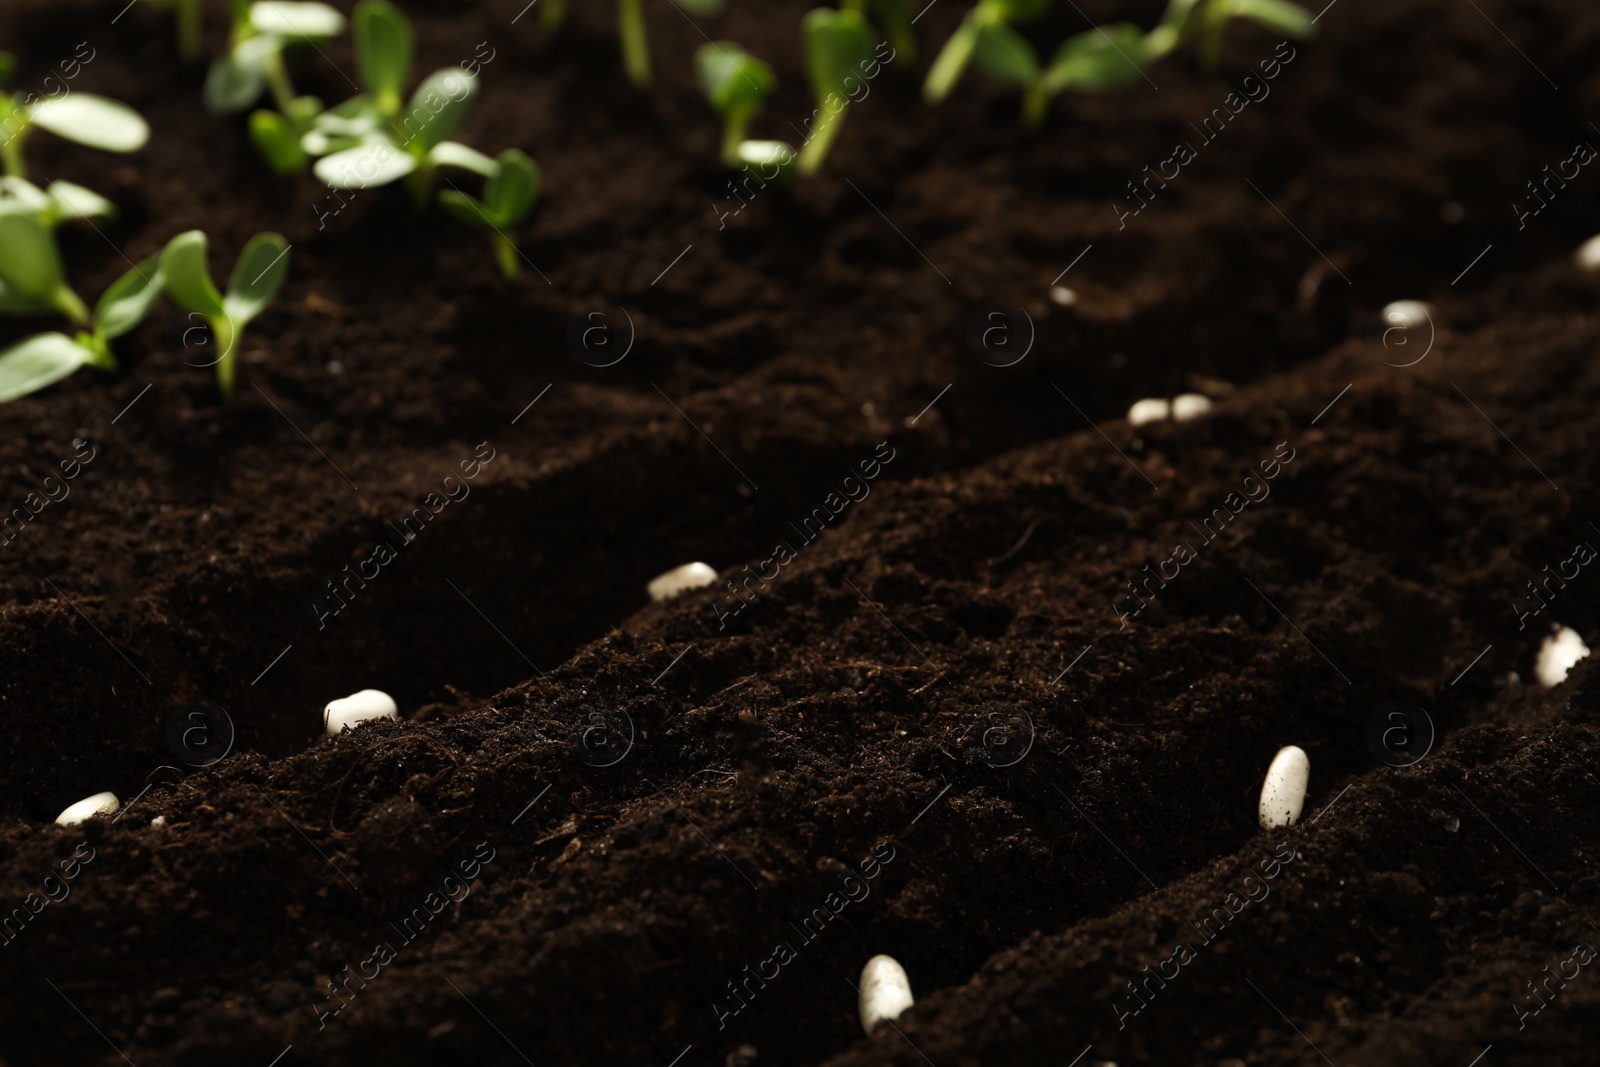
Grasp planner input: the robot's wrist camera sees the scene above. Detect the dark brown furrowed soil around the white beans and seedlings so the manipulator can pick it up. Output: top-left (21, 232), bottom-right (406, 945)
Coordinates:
top-left (0, 0), bottom-right (1600, 1067)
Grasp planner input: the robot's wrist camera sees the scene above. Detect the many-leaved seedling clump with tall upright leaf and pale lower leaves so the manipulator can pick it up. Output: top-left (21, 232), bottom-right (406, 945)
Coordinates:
top-left (301, 0), bottom-right (494, 206)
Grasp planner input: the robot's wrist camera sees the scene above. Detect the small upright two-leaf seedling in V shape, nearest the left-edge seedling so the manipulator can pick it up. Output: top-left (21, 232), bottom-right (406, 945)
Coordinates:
top-left (160, 230), bottom-right (290, 403)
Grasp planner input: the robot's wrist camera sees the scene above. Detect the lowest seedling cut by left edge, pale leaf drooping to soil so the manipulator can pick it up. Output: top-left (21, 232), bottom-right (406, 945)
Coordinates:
top-left (0, 202), bottom-right (163, 402)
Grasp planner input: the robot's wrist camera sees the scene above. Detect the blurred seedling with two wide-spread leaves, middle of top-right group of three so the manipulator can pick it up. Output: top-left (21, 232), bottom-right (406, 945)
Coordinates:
top-left (973, 22), bottom-right (1144, 128)
